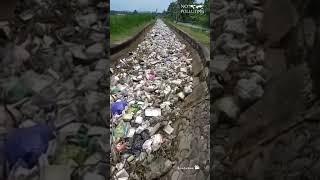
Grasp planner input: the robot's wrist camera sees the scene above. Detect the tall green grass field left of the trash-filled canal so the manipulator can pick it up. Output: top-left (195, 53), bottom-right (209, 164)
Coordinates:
top-left (110, 14), bottom-right (155, 44)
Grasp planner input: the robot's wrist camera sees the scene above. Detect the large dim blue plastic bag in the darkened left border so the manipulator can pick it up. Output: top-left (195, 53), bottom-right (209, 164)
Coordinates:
top-left (5, 124), bottom-right (54, 168)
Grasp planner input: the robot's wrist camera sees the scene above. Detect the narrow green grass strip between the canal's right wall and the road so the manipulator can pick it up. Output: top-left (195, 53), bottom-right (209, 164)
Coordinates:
top-left (166, 20), bottom-right (210, 48)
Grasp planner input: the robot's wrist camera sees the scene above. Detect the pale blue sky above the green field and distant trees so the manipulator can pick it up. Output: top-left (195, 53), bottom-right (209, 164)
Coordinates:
top-left (110, 0), bottom-right (204, 12)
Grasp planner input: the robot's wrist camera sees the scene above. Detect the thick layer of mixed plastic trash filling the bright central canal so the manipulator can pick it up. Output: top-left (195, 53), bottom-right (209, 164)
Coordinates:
top-left (110, 20), bottom-right (193, 180)
